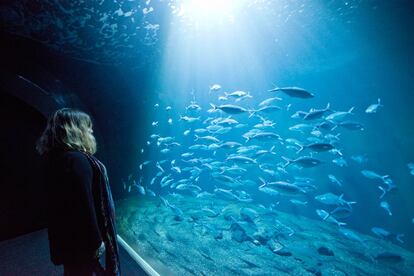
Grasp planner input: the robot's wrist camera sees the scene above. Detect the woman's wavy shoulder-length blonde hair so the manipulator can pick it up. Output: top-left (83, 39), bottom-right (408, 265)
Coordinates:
top-left (36, 108), bottom-right (96, 154)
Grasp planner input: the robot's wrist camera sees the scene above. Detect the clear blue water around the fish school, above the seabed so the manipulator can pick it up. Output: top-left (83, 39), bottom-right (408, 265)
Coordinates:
top-left (132, 1), bottom-right (414, 250)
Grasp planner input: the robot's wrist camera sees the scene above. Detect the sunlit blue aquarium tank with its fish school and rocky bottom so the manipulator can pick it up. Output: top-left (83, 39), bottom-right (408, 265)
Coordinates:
top-left (118, 1), bottom-right (414, 275)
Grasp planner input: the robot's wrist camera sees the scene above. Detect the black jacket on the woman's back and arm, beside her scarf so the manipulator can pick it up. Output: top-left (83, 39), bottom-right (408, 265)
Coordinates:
top-left (46, 151), bottom-right (102, 265)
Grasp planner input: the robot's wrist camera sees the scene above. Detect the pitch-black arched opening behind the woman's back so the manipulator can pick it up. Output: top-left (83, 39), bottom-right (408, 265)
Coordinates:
top-left (0, 94), bottom-right (46, 240)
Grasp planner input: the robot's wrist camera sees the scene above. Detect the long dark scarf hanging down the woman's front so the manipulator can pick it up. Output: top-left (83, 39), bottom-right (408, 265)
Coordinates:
top-left (84, 152), bottom-right (120, 276)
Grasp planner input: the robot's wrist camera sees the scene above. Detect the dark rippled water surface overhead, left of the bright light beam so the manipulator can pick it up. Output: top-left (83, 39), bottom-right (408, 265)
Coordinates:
top-left (0, 0), bottom-right (165, 66)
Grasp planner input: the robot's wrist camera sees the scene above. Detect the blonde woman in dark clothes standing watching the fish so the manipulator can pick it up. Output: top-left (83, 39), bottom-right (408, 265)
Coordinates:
top-left (36, 108), bottom-right (120, 276)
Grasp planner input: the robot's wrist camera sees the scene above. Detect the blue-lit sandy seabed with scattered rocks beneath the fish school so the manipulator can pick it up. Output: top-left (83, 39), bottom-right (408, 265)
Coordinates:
top-left (116, 195), bottom-right (414, 275)
